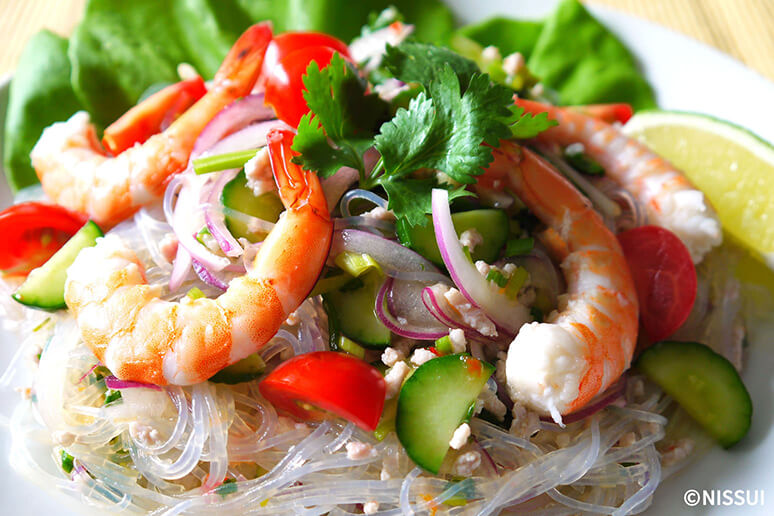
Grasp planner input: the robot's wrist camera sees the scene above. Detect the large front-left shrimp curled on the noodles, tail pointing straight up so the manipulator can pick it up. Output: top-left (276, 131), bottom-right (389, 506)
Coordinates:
top-left (65, 129), bottom-right (333, 385)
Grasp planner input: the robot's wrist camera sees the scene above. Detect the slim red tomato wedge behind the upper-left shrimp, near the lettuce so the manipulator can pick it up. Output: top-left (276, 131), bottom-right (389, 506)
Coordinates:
top-left (102, 77), bottom-right (207, 156)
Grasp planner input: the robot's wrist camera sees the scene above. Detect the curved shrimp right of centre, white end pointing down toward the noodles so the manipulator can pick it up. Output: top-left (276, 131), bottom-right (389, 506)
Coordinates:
top-left (483, 142), bottom-right (638, 422)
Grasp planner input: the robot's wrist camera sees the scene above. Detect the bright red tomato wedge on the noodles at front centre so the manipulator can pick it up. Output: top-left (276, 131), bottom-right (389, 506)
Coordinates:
top-left (259, 351), bottom-right (386, 431)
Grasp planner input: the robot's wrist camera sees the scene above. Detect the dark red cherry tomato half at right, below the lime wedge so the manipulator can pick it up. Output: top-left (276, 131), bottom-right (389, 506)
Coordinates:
top-left (618, 226), bottom-right (696, 341)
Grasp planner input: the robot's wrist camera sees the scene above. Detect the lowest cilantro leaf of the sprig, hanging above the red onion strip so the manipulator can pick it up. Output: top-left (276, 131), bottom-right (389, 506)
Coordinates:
top-left (379, 176), bottom-right (473, 226)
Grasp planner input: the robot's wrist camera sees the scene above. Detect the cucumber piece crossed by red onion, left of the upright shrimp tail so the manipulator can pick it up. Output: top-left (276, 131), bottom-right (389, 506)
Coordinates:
top-left (220, 170), bottom-right (285, 243)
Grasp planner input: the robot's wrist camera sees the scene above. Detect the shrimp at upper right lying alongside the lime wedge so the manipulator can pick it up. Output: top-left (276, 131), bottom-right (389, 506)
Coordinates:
top-left (516, 99), bottom-right (723, 263)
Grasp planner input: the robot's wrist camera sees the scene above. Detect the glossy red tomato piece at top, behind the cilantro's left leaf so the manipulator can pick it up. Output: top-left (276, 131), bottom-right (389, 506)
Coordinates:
top-left (265, 47), bottom-right (346, 127)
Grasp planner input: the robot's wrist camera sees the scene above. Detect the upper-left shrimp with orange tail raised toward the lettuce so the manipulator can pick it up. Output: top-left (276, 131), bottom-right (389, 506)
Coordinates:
top-left (30, 24), bottom-right (272, 227)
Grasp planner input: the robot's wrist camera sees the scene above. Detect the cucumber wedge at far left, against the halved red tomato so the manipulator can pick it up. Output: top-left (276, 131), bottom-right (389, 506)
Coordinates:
top-left (13, 221), bottom-right (102, 310)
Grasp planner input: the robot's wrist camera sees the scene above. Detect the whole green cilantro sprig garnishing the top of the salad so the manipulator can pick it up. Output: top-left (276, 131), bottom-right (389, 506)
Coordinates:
top-left (293, 42), bottom-right (555, 226)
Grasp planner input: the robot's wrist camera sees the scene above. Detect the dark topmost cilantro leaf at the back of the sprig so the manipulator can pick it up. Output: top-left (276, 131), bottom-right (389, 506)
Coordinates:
top-left (382, 42), bottom-right (479, 93)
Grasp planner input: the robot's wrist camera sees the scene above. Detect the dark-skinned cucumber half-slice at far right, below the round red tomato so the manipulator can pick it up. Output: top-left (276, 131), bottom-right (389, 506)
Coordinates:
top-left (636, 341), bottom-right (753, 448)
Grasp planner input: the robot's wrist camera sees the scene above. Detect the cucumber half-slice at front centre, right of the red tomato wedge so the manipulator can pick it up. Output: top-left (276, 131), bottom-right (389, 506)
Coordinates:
top-left (395, 354), bottom-right (494, 474)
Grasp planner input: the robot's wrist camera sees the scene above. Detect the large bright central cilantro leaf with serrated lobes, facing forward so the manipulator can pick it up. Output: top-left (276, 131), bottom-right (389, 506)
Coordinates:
top-left (376, 65), bottom-right (512, 184)
